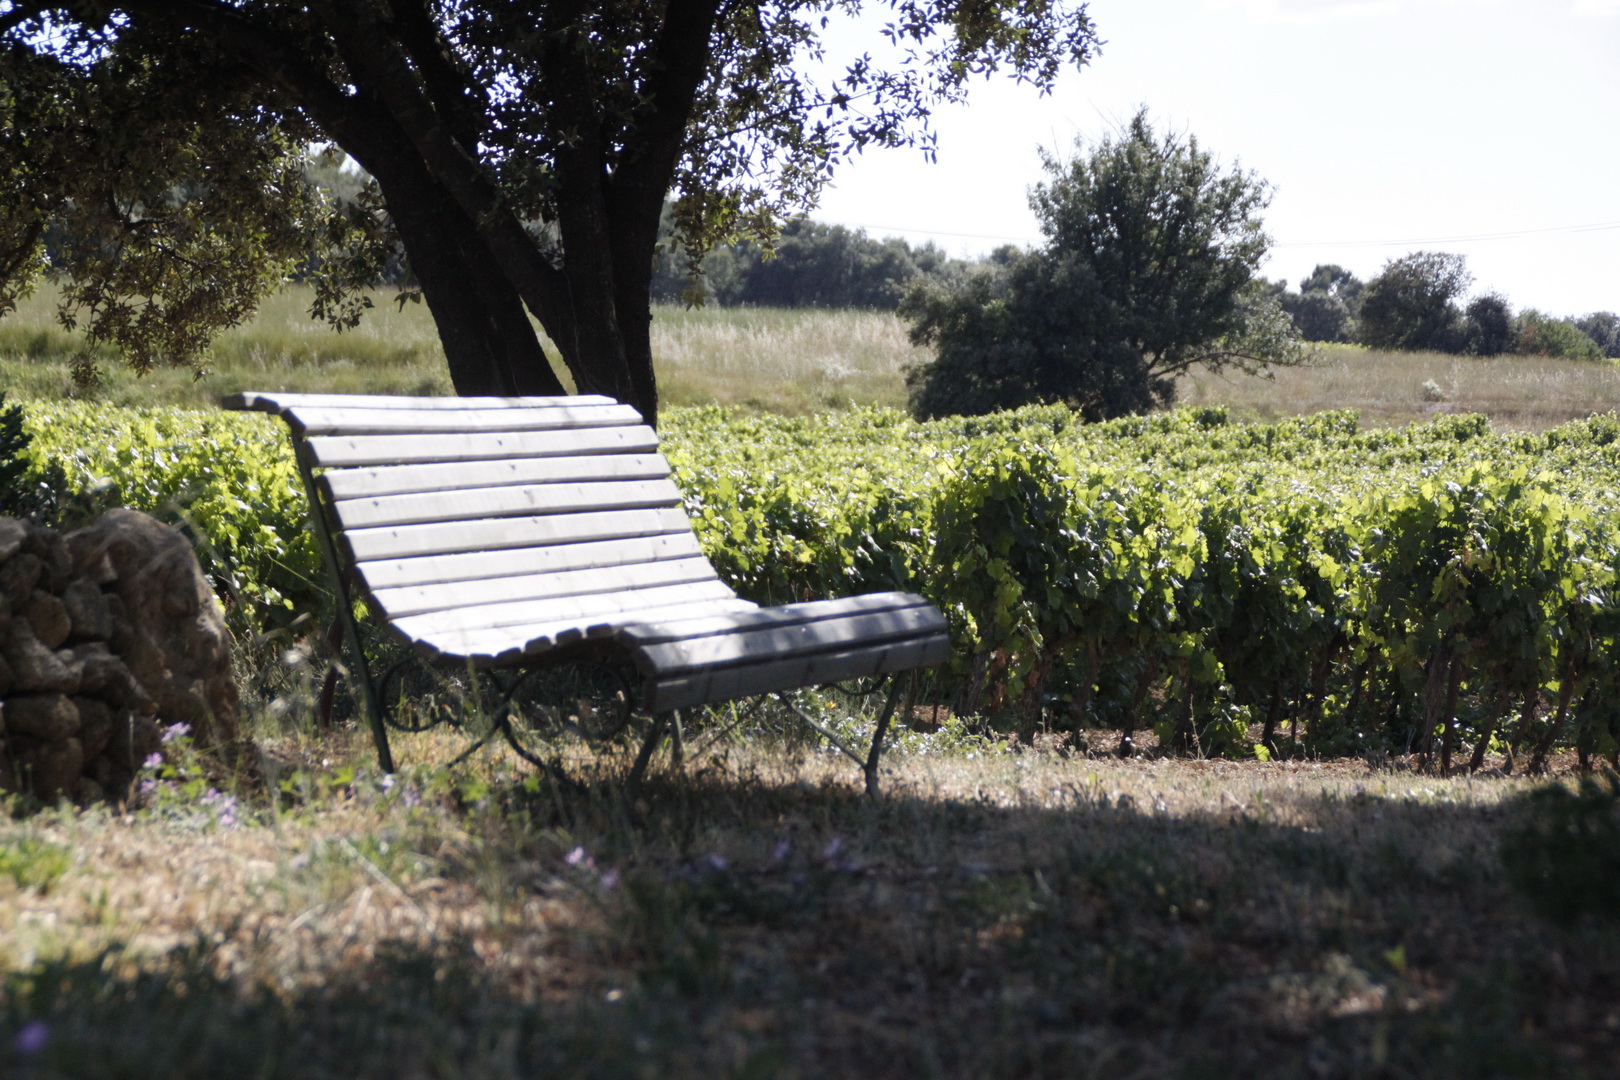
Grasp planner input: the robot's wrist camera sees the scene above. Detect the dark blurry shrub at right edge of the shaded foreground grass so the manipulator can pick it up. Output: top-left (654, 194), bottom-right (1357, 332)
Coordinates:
top-left (1502, 772), bottom-right (1620, 923)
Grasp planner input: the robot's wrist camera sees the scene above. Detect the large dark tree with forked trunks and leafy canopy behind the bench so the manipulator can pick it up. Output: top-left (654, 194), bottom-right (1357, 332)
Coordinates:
top-left (0, 0), bottom-right (1098, 419)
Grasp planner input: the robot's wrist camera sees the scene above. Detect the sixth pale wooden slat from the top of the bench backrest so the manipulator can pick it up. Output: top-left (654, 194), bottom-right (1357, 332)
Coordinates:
top-left (340, 507), bottom-right (692, 562)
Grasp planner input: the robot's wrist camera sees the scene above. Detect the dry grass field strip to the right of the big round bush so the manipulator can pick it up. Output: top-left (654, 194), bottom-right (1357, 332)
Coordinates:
top-left (1178, 345), bottom-right (1620, 431)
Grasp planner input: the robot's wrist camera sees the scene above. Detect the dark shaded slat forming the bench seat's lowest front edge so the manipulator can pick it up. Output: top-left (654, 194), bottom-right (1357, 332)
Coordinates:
top-left (643, 633), bottom-right (951, 712)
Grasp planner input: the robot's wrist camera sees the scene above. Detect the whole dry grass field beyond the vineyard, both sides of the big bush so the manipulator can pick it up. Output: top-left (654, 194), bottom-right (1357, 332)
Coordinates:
top-left (9, 288), bottom-right (1620, 431)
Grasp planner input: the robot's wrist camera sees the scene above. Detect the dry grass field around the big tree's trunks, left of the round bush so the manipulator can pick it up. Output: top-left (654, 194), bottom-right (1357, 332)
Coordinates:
top-left (0, 287), bottom-right (920, 413)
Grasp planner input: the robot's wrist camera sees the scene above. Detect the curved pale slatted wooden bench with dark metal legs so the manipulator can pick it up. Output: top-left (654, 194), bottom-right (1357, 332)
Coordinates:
top-left (224, 393), bottom-right (949, 792)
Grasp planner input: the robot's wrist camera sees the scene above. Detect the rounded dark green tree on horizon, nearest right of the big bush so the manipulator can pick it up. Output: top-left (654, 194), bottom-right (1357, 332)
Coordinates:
top-left (1358, 251), bottom-right (1473, 353)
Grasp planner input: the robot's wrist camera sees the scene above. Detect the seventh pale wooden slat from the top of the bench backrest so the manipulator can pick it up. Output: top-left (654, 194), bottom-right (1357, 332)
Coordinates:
top-left (360, 529), bottom-right (703, 591)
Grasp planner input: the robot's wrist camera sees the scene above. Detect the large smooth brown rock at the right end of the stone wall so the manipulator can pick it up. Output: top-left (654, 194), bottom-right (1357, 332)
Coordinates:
top-left (70, 510), bottom-right (237, 746)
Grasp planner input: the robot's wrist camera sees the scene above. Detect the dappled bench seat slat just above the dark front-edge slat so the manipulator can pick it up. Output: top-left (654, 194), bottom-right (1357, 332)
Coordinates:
top-left (635, 607), bottom-right (944, 680)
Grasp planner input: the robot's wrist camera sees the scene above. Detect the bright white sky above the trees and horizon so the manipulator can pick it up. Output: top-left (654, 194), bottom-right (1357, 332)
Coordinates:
top-left (813, 0), bottom-right (1620, 316)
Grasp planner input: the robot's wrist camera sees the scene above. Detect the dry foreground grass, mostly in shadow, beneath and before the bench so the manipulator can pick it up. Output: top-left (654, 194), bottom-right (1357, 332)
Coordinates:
top-left (0, 722), bottom-right (1620, 1080)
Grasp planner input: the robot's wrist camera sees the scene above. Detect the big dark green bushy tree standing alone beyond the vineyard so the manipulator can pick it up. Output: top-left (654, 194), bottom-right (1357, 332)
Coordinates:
top-left (901, 112), bottom-right (1302, 419)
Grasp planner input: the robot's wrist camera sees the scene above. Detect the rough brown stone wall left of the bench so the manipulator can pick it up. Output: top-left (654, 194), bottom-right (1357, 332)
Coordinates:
top-left (0, 510), bottom-right (237, 801)
